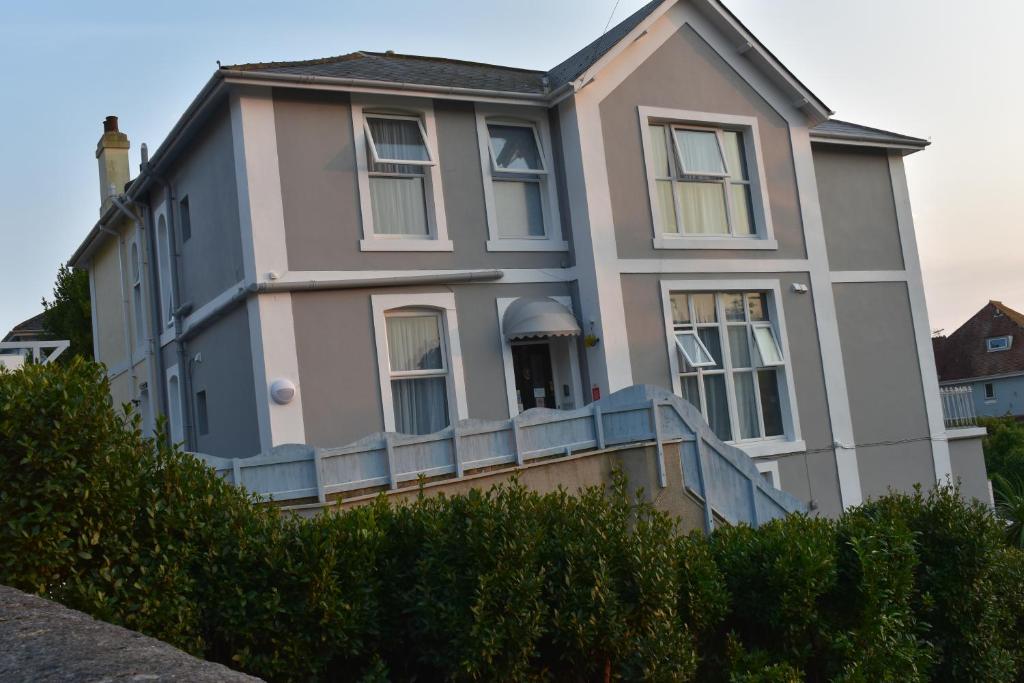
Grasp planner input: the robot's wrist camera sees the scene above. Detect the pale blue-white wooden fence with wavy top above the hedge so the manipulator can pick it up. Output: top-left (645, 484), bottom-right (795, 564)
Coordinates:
top-left (197, 386), bottom-right (804, 529)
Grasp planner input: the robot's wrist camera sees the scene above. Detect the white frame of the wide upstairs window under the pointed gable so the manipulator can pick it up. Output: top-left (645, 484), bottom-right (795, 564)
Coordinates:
top-left (637, 105), bottom-right (778, 250)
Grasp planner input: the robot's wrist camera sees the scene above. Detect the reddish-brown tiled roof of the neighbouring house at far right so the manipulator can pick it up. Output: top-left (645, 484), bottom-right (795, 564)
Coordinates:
top-left (932, 301), bottom-right (1024, 382)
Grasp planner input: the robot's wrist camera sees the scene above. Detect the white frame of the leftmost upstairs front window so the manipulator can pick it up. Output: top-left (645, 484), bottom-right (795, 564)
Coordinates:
top-left (351, 93), bottom-right (455, 252)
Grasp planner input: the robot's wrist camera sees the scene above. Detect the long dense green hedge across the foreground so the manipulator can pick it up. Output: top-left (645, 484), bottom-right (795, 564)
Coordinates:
top-left (0, 361), bottom-right (1024, 682)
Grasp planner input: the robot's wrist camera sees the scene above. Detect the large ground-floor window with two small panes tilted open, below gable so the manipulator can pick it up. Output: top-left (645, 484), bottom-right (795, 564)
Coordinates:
top-left (669, 292), bottom-right (786, 441)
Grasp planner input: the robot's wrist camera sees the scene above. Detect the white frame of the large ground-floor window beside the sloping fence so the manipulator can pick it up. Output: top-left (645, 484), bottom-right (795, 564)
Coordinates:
top-left (660, 280), bottom-right (807, 458)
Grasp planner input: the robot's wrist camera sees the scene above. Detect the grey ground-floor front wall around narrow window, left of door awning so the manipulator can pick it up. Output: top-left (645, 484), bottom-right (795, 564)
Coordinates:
top-left (292, 283), bottom-right (571, 447)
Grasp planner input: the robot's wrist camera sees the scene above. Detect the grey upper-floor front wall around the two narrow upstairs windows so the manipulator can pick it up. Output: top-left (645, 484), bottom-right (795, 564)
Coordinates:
top-left (274, 90), bottom-right (568, 270)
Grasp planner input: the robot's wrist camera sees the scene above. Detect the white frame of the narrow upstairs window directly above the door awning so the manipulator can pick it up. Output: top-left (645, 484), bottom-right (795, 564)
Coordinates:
top-left (476, 102), bottom-right (569, 252)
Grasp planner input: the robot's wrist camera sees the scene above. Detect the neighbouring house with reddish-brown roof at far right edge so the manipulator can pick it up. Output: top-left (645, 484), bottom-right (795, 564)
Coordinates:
top-left (932, 301), bottom-right (1024, 418)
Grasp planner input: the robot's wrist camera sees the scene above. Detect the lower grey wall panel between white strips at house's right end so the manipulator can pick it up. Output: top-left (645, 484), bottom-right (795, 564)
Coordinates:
top-left (834, 283), bottom-right (935, 498)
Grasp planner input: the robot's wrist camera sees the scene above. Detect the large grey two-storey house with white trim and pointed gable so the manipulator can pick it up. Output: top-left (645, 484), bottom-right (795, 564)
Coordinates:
top-left (73, 0), bottom-right (987, 514)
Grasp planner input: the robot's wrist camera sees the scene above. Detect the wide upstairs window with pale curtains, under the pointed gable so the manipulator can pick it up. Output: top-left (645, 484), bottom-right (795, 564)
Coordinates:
top-left (649, 124), bottom-right (757, 238)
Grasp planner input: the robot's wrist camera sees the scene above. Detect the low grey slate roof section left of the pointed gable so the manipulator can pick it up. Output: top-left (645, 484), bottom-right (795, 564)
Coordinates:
top-left (223, 51), bottom-right (546, 94)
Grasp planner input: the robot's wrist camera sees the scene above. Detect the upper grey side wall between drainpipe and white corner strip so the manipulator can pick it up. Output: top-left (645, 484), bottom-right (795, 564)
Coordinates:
top-left (169, 105), bottom-right (244, 310)
